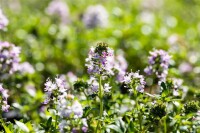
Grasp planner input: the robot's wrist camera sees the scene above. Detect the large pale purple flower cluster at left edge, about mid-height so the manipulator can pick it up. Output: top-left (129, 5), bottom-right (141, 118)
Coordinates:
top-left (0, 42), bottom-right (20, 74)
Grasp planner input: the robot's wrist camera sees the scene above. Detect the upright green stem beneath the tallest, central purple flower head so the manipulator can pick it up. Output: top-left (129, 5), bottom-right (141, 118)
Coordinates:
top-left (95, 75), bottom-right (103, 133)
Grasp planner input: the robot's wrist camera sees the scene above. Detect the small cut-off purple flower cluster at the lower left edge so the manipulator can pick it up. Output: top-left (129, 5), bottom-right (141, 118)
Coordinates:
top-left (0, 84), bottom-right (10, 112)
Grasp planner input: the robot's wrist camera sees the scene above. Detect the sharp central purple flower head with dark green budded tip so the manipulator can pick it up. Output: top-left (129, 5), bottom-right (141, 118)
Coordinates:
top-left (86, 43), bottom-right (114, 75)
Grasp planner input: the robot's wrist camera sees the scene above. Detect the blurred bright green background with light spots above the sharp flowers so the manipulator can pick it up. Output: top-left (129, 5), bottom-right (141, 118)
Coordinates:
top-left (0, 0), bottom-right (200, 91)
